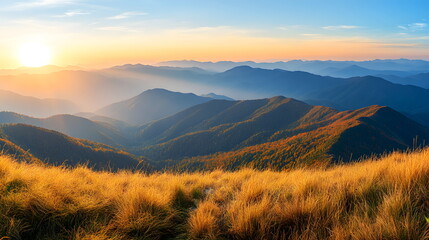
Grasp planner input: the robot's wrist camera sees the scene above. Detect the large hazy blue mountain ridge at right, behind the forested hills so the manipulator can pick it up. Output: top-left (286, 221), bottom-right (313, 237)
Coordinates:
top-left (188, 66), bottom-right (429, 125)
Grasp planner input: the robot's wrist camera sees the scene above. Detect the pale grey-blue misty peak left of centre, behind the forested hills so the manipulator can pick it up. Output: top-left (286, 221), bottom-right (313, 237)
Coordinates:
top-left (97, 89), bottom-right (212, 125)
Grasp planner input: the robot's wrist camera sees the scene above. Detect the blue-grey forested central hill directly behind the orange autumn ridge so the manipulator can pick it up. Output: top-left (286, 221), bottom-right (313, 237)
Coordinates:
top-left (137, 97), bottom-right (326, 148)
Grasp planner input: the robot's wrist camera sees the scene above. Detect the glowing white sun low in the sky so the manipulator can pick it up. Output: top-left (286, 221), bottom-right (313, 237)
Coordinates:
top-left (19, 43), bottom-right (52, 67)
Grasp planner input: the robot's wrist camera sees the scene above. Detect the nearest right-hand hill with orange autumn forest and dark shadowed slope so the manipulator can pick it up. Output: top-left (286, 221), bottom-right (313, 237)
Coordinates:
top-left (175, 106), bottom-right (429, 171)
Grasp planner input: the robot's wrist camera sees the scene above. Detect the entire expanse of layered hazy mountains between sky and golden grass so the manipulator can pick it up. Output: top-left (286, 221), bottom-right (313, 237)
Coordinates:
top-left (0, 59), bottom-right (429, 170)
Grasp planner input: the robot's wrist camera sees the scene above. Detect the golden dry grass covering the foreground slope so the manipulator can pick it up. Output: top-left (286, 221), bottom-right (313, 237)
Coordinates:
top-left (0, 149), bottom-right (429, 240)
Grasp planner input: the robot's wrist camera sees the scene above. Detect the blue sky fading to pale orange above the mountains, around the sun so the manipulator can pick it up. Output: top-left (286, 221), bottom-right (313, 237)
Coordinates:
top-left (0, 0), bottom-right (429, 68)
